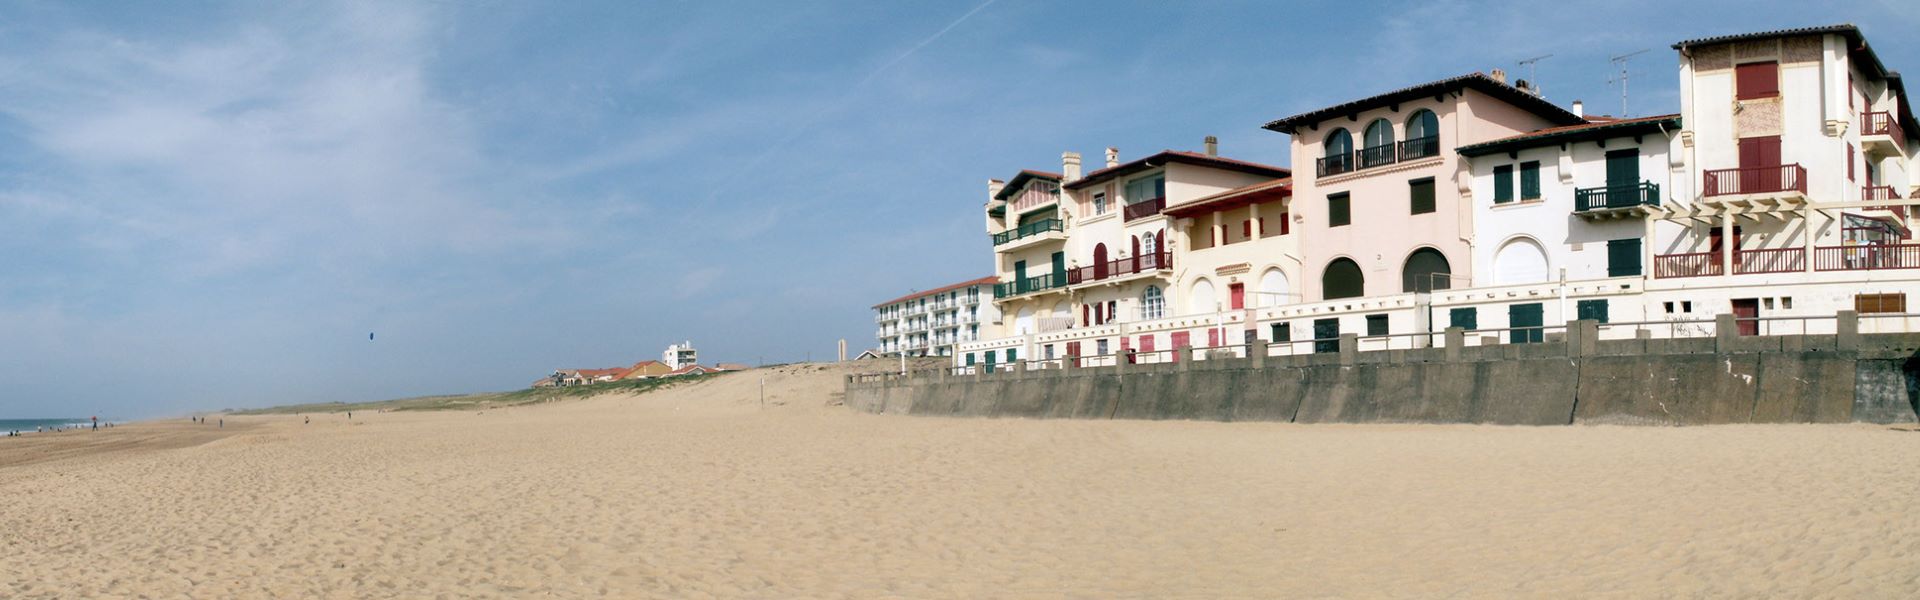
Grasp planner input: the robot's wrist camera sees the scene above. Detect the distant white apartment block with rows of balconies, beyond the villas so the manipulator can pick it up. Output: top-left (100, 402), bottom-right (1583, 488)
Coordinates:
top-left (874, 277), bottom-right (1000, 356)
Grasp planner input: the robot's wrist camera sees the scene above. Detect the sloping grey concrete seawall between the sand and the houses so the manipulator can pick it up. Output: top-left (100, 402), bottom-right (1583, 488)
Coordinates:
top-left (847, 327), bottom-right (1920, 425)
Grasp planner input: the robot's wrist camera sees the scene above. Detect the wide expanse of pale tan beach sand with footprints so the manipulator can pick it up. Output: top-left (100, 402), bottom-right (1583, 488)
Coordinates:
top-left (0, 367), bottom-right (1920, 598)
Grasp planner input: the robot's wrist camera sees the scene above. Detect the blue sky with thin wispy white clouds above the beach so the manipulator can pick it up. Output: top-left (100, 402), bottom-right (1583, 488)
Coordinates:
top-left (0, 0), bottom-right (1920, 419)
